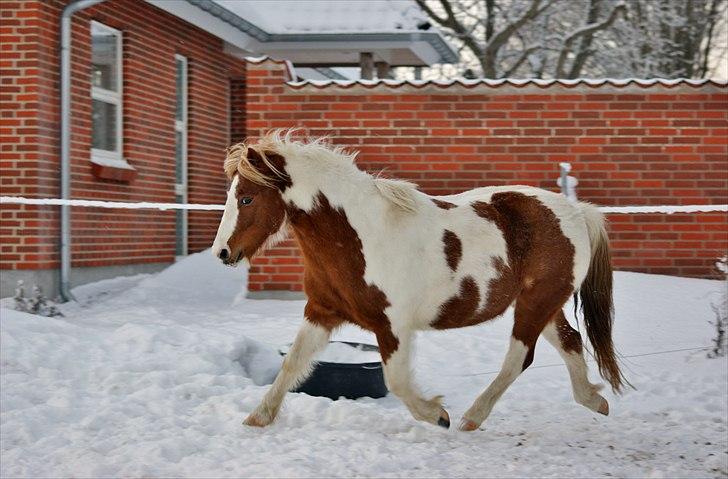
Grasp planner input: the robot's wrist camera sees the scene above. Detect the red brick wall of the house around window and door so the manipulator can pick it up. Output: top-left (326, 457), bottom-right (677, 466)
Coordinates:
top-left (0, 0), bottom-right (245, 269)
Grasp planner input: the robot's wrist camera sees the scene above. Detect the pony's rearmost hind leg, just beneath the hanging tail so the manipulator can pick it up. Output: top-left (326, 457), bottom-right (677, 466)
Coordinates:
top-left (543, 310), bottom-right (609, 416)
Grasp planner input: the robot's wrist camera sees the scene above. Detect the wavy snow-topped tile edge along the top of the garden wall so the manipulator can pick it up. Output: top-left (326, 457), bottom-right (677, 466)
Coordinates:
top-left (287, 77), bottom-right (728, 89)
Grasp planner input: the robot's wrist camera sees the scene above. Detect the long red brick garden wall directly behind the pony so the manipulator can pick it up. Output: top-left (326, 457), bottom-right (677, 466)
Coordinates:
top-left (247, 61), bottom-right (728, 291)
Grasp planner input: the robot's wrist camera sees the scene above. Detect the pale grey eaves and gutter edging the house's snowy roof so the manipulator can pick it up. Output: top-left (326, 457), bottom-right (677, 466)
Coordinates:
top-left (146, 0), bottom-right (458, 66)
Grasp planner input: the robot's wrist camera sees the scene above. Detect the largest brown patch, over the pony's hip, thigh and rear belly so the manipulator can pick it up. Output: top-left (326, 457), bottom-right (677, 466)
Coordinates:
top-left (432, 192), bottom-right (574, 344)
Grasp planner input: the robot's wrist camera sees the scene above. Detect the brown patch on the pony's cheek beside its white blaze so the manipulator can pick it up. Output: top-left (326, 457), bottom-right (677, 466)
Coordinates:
top-left (228, 176), bottom-right (286, 261)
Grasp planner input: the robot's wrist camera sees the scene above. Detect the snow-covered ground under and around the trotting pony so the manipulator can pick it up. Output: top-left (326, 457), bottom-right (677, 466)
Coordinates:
top-left (0, 252), bottom-right (728, 477)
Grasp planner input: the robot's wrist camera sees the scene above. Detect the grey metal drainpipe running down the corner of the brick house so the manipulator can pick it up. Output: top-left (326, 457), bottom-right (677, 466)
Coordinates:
top-left (60, 0), bottom-right (106, 301)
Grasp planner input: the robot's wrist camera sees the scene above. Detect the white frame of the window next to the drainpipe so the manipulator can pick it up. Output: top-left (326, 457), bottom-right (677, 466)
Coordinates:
top-left (90, 20), bottom-right (126, 169)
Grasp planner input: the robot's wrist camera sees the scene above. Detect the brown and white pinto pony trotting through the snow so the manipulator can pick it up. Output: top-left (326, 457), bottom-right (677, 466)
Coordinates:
top-left (212, 132), bottom-right (626, 431)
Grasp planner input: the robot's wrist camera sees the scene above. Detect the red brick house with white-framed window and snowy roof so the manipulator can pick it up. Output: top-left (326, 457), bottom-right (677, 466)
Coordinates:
top-left (0, 0), bottom-right (456, 297)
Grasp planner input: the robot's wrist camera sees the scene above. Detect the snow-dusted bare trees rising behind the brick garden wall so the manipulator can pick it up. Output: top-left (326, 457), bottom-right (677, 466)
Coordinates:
top-left (415, 0), bottom-right (728, 78)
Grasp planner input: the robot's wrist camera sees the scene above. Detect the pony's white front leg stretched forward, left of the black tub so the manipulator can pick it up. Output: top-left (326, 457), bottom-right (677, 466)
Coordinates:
top-left (243, 318), bottom-right (331, 427)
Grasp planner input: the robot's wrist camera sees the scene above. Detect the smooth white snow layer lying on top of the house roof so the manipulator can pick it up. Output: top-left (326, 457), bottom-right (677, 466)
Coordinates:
top-left (214, 0), bottom-right (427, 34)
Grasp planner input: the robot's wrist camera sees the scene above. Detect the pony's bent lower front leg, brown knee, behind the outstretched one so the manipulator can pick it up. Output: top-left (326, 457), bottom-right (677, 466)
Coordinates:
top-left (377, 331), bottom-right (450, 429)
